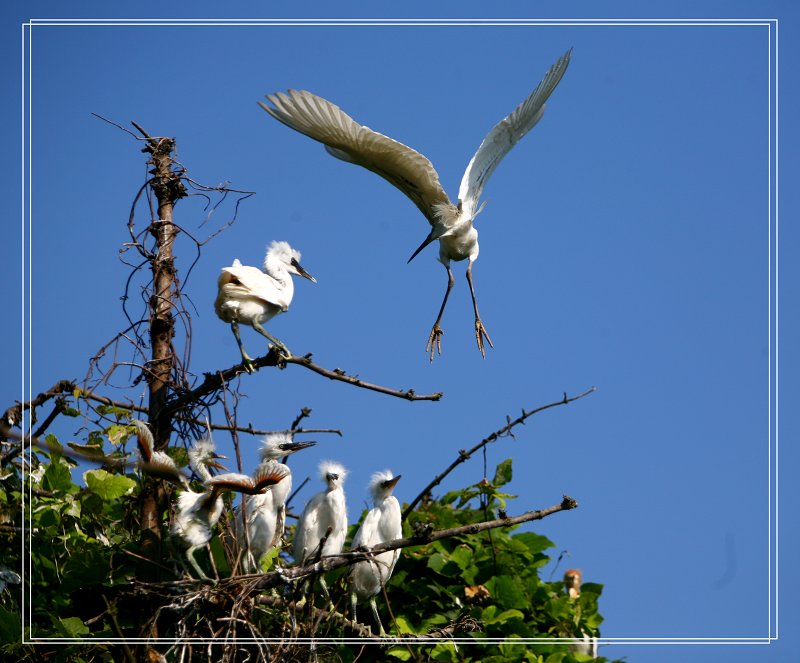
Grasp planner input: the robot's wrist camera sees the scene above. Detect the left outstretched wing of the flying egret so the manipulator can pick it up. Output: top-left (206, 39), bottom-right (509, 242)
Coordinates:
top-left (259, 90), bottom-right (450, 224)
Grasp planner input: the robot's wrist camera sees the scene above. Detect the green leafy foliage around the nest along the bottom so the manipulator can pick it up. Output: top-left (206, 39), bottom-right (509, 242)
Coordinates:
top-left (0, 434), bottom-right (620, 663)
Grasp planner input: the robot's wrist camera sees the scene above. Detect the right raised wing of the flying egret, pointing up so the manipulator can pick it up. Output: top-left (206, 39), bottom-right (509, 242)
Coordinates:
top-left (458, 49), bottom-right (572, 216)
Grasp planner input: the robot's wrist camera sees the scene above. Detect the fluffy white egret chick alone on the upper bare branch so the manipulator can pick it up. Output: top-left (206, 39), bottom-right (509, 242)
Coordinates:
top-left (219, 241), bottom-right (317, 373)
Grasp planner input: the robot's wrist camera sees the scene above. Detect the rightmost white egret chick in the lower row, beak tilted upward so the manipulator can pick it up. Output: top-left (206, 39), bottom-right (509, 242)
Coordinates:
top-left (350, 470), bottom-right (403, 637)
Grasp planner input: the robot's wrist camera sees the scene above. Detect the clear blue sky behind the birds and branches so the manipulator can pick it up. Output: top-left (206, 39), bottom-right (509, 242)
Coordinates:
top-left (0, 2), bottom-right (800, 662)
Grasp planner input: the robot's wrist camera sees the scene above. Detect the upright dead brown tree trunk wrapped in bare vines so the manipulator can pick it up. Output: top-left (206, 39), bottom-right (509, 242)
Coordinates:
top-left (133, 123), bottom-right (186, 581)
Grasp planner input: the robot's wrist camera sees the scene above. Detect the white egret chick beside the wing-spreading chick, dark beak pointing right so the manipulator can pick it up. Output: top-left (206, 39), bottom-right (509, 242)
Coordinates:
top-left (233, 433), bottom-right (316, 572)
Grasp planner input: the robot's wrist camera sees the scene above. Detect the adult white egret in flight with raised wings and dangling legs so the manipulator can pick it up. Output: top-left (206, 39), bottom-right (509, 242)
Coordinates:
top-left (259, 49), bottom-right (572, 361)
